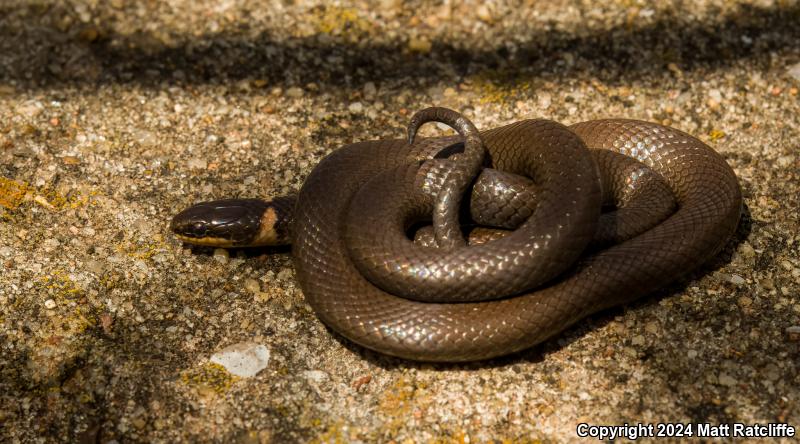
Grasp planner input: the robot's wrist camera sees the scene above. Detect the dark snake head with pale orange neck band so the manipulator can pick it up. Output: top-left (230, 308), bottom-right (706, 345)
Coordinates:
top-left (170, 199), bottom-right (288, 248)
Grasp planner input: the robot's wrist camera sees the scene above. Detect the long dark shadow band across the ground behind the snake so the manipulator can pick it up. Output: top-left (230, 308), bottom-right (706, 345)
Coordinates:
top-left (0, 1), bottom-right (800, 89)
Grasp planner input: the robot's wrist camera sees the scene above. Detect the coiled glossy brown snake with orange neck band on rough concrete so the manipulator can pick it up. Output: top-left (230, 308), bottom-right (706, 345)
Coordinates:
top-left (171, 107), bottom-right (742, 362)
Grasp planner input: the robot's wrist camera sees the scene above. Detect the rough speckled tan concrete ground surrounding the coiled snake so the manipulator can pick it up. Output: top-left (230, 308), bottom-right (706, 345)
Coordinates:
top-left (0, 0), bottom-right (800, 443)
